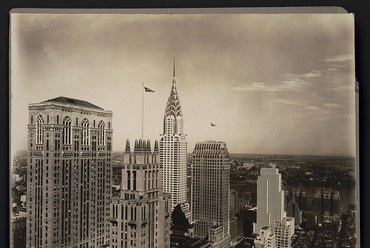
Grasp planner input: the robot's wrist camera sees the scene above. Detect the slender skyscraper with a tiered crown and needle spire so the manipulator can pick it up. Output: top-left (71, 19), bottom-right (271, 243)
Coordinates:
top-left (160, 64), bottom-right (190, 215)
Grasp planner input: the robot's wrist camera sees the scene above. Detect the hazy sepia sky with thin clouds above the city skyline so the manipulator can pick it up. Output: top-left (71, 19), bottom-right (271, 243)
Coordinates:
top-left (11, 14), bottom-right (355, 155)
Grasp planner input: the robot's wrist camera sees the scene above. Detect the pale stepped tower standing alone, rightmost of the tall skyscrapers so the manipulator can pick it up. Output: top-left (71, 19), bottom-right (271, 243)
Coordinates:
top-left (254, 167), bottom-right (284, 233)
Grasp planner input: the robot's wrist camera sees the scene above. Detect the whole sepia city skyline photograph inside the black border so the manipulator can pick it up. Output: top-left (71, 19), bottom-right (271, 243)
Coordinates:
top-left (9, 9), bottom-right (360, 248)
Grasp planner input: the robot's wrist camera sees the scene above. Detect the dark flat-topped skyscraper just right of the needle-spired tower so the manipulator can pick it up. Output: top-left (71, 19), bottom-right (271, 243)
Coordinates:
top-left (191, 141), bottom-right (230, 247)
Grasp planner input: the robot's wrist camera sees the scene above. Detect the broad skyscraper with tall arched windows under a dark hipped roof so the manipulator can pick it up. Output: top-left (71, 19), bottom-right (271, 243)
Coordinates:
top-left (26, 97), bottom-right (113, 248)
